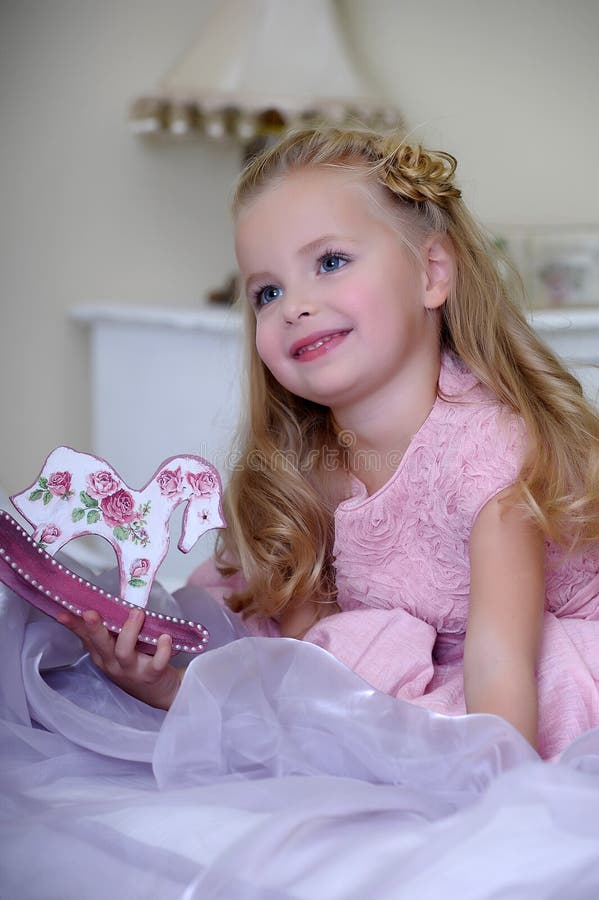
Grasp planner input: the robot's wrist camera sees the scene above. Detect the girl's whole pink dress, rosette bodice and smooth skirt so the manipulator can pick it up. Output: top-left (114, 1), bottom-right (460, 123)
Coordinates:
top-left (305, 355), bottom-right (599, 757)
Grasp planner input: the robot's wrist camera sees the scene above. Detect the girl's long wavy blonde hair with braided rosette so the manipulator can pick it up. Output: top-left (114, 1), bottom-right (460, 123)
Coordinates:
top-left (218, 128), bottom-right (599, 616)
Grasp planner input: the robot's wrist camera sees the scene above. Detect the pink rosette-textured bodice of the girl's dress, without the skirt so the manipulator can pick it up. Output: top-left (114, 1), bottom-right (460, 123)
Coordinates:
top-left (334, 354), bottom-right (599, 633)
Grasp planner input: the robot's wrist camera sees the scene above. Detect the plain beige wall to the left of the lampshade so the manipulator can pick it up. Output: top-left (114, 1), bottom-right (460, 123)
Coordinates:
top-left (0, 0), bottom-right (239, 491)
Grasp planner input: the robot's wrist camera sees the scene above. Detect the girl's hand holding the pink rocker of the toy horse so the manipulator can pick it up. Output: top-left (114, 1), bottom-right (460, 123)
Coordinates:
top-left (58, 609), bottom-right (183, 709)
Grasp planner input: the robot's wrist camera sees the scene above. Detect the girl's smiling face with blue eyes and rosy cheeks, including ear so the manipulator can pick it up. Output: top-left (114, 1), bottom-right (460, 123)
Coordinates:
top-left (236, 168), bottom-right (447, 414)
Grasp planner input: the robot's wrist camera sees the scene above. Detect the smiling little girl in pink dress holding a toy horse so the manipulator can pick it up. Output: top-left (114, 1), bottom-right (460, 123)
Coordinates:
top-left (63, 129), bottom-right (599, 757)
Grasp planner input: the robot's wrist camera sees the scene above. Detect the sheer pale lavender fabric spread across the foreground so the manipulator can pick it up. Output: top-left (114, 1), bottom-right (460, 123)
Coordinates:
top-left (0, 588), bottom-right (599, 900)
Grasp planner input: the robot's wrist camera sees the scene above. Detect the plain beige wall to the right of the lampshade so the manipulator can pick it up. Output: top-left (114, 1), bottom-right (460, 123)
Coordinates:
top-left (345, 0), bottom-right (599, 224)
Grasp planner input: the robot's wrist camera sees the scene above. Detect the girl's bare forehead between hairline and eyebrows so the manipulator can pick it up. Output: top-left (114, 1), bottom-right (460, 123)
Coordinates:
top-left (235, 166), bottom-right (391, 248)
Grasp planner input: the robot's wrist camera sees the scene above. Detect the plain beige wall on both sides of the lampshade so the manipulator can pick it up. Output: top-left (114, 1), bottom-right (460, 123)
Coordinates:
top-left (0, 0), bottom-right (599, 491)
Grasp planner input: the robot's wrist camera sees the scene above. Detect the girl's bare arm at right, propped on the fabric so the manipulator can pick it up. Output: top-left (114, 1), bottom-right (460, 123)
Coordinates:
top-left (464, 491), bottom-right (545, 746)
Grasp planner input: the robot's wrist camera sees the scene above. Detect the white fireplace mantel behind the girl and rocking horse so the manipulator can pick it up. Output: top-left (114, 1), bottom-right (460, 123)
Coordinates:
top-left (71, 303), bottom-right (599, 586)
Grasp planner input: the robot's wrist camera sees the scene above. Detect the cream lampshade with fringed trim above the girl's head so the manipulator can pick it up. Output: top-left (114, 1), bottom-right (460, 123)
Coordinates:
top-left (130, 0), bottom-right (403, 144)
